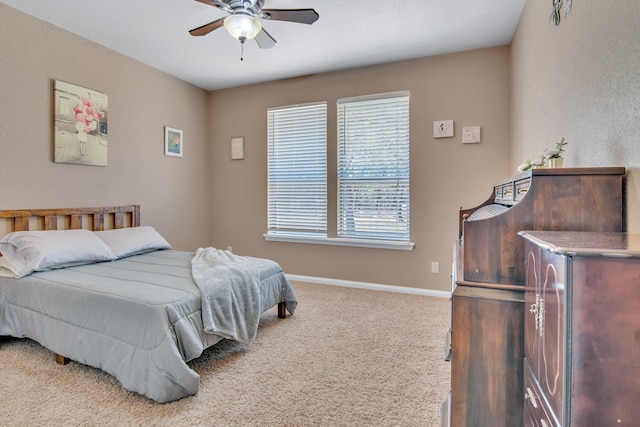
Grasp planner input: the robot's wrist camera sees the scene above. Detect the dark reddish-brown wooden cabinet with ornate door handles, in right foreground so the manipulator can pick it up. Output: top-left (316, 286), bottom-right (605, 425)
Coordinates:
top-left (521, 231), bottom-right (640, 427)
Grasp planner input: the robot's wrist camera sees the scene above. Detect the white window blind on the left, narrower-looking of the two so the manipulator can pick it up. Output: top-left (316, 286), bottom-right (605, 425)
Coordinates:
top-left (267, 102), bottom-right (327, 237)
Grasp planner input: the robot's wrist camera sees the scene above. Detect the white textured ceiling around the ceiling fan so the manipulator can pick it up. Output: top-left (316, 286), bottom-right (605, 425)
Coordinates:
top-left (1, 0), bottom-right (525, 90)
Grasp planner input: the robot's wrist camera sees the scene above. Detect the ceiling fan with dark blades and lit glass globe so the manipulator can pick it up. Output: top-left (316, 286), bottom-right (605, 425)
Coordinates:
top-left (189, 0), bottom-right (320, 59)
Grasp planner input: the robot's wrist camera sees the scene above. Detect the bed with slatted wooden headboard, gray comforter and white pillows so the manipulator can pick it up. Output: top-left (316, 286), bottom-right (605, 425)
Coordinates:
top-left (0, 205), bottom-right (297, 403)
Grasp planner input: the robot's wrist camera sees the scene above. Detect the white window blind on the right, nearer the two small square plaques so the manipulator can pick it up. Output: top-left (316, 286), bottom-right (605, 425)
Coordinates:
top-left (338, 92), bottom-right (410, 241)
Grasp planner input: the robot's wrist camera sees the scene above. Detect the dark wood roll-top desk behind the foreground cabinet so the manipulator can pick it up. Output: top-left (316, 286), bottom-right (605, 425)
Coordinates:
top-left (442, 167), bottom-right (625, 427)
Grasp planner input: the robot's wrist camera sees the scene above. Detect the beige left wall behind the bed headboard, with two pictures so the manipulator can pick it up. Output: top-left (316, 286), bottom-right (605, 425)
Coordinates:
top-left (0, 4), bottom-right (211, 250)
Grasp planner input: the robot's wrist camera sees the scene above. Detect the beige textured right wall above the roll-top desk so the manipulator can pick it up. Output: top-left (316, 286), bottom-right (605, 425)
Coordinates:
top-left (511, 0), bottom-right (640, 232)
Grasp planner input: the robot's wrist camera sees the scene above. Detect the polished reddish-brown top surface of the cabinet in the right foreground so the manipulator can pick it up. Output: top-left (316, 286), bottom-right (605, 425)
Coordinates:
top-left (518, 231), bottom-right (640, 258)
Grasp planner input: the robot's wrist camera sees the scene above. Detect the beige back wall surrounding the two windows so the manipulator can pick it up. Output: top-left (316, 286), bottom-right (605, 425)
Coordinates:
top-left (209, 47), bottom-right (510, 290)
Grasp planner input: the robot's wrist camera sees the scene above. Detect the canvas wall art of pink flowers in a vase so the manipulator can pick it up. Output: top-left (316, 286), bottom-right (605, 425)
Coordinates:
top-left (53, 80), bottom-right (109, 166)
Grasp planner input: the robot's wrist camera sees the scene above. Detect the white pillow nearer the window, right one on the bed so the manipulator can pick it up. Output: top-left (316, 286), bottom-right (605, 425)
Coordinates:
top-left (95, 226), bottom-right (171, 258)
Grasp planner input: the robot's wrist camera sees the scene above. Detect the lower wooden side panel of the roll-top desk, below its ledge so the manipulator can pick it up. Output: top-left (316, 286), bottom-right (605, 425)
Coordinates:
top-left (451, 286), bottom-right (524, 427)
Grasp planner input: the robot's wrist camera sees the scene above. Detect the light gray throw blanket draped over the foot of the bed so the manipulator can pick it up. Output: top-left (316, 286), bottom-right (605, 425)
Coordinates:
top-left (191, 248), bottom-right (261, 344)
